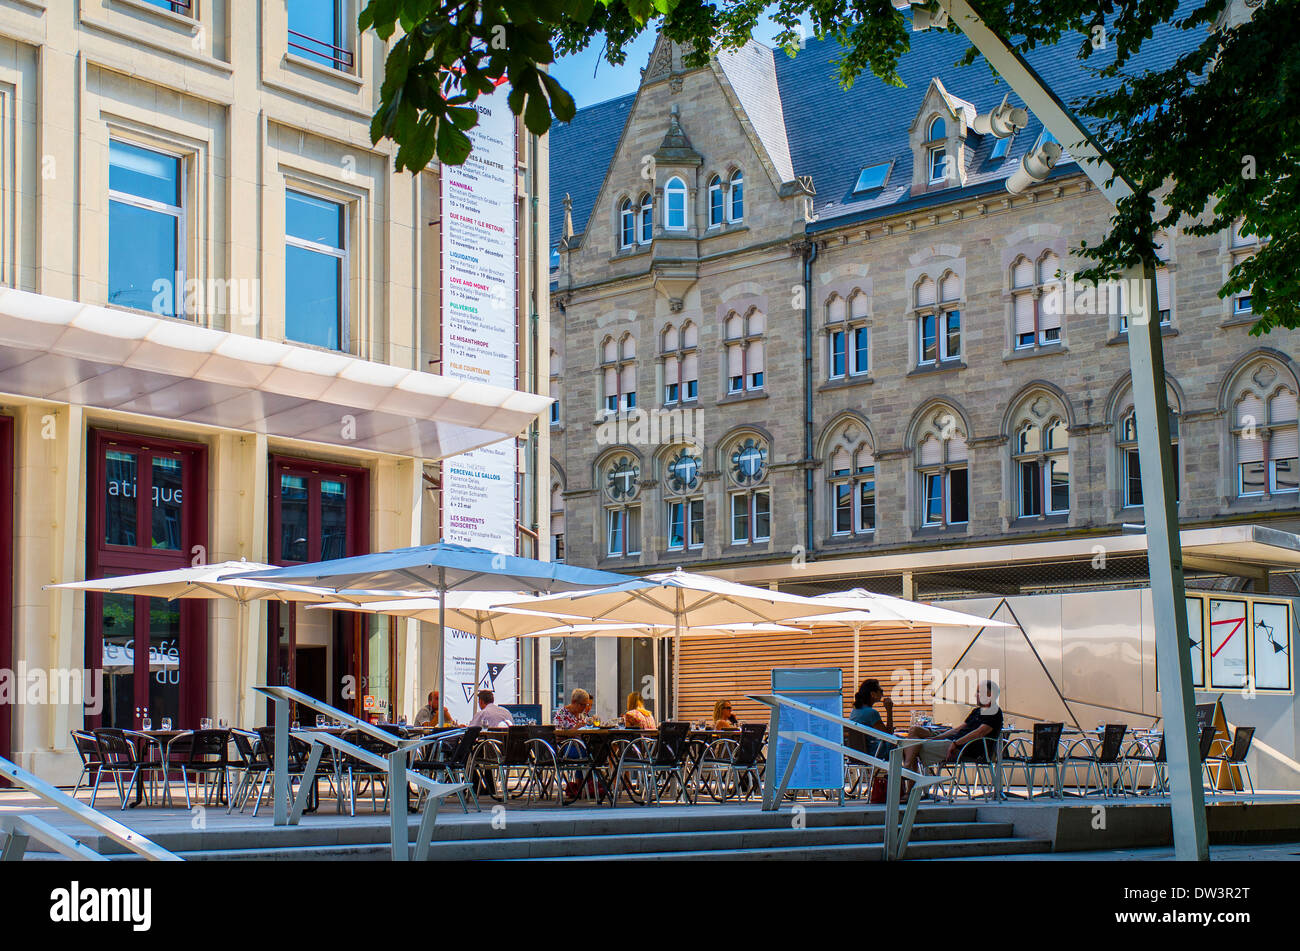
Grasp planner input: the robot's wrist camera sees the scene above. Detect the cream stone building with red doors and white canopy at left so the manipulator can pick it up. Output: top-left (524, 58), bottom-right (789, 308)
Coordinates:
top-left (0, 0), bottom-right (550, 782)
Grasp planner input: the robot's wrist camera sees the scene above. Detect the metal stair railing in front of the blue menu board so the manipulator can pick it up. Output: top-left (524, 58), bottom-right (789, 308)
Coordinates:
top-left (749, 694), bottom-right (945, 861)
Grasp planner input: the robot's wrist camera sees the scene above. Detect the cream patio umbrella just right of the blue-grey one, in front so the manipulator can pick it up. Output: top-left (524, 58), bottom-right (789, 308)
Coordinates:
top-left (488, 568), bottom-right (844, 712)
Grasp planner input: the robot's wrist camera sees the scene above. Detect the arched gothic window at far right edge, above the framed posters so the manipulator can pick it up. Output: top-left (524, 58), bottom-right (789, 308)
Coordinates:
top-left (1232, 364), bottom-right (1300, 498)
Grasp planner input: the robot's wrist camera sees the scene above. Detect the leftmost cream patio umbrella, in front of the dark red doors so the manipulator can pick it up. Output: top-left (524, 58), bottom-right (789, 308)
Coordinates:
top-left (46, 561), bottom-right (421, 722)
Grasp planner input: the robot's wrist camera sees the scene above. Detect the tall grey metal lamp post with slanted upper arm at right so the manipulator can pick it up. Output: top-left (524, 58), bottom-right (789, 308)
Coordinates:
top-left (894, 0), bottom-right (1209, 861)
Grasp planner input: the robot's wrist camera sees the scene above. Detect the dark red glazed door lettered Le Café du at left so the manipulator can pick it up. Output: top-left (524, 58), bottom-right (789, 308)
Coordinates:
top-left (86, 430), bottom-right (208, 729)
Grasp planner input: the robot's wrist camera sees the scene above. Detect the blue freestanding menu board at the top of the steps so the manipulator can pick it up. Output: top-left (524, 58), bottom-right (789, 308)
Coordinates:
top-left (768, 666), bottom-right (844, 789)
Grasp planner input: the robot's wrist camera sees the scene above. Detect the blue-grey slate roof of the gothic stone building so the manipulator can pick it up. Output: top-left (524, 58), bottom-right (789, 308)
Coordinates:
top-left (550, 14), bottom-right (1203, 247)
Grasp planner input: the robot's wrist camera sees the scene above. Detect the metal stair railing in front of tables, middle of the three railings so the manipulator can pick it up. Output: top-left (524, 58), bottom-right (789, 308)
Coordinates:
top-left (254, 686), bottom-right (469, 861)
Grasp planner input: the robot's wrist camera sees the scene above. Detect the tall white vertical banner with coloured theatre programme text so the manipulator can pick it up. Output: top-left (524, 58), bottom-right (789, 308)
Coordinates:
top-left (442, 84), bottom-right (519, 721)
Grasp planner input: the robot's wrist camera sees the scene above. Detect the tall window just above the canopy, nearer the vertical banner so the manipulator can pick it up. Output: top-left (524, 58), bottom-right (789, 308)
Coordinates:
top-left (285, 191), bottom-right (350, 351)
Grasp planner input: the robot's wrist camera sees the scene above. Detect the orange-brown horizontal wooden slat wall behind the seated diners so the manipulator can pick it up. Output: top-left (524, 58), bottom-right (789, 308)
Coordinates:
top-left (677, 628), bottom-right (932, 726)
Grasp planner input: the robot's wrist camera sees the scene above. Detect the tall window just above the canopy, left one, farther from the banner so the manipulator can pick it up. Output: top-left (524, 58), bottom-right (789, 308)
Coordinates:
top-left (108, 139), bottom-right (186, 317)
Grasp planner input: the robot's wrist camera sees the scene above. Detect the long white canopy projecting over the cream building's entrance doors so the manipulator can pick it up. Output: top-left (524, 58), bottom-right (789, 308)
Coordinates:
top-left (0, 290), bottom-right (551, 460)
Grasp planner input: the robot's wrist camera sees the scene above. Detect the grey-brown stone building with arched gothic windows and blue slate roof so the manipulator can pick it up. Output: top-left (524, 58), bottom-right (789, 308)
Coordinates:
top-left (551, 24), bottom-right (1300, 713)
